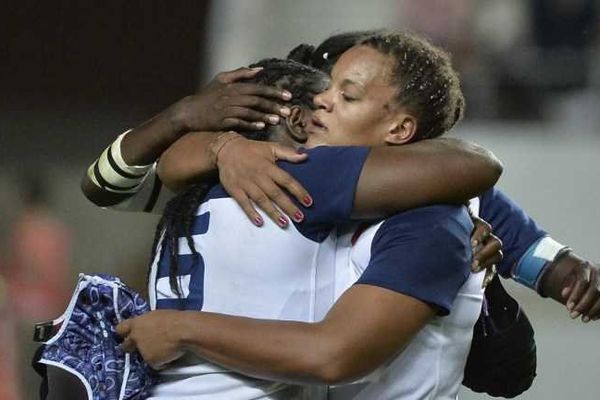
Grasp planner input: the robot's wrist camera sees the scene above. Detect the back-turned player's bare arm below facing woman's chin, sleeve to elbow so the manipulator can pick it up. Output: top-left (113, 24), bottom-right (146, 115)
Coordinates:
top-left (354, 138), bottom-right (502, 217)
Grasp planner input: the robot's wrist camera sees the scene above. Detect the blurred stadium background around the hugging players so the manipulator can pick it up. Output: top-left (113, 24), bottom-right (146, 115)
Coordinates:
top-left (0, 0), bottom-right (600, 400)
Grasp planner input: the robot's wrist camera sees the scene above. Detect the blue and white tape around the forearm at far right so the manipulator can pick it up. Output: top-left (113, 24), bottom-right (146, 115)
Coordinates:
top-left (512, 236), bottom-right (567, 291)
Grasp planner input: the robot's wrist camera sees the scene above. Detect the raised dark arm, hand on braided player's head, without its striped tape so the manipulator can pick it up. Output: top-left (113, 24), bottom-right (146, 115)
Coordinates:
top-left (81, 68), bottom-right (290, 206)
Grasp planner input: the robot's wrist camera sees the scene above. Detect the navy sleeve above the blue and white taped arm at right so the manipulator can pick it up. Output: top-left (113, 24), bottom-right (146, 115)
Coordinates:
top-left (479, 188), bottom-right (547, 278)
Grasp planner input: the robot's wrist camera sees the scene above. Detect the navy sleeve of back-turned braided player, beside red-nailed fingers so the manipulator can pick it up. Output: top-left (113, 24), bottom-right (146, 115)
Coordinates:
top-left (279, 146), bottom-right (369, 241)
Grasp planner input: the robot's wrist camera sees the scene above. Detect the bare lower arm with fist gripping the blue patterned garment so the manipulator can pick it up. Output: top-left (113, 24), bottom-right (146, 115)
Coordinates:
top-left (117, 285), bottom-right (435, 384)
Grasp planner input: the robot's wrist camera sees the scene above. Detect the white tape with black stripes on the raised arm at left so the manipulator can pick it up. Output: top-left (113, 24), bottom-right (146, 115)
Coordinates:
top-left (88, 131), bottom-right (152, 193)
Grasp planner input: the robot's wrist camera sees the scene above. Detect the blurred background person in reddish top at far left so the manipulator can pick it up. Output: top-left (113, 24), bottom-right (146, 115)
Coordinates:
top-left (5, 174), bottom-right (71, 398)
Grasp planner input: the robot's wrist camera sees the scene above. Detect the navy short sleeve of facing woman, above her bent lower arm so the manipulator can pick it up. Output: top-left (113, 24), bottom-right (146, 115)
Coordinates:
top-left (356, 205), bottom-right (473, 315)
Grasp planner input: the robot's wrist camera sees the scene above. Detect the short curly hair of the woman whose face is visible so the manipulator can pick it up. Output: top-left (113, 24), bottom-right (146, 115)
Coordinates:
top-left (359, 31), bottom-right (465, 141)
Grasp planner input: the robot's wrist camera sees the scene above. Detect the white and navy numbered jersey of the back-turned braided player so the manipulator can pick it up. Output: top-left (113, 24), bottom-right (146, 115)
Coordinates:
top-left (149, 147), bottom-right (368, 400)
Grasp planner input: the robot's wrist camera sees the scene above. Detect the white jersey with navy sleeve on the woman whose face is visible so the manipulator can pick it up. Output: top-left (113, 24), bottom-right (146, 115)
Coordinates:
top-left (329, 206), bottom-right (483, 400)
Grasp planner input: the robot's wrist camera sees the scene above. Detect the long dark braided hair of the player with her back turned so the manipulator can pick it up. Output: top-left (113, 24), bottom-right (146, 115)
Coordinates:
top-left (151, 58), bottom-right (328, 296)
